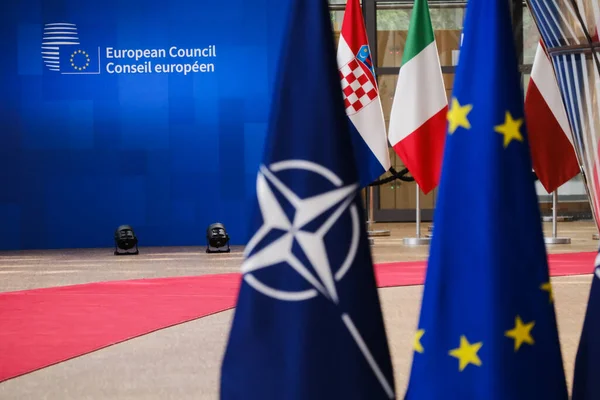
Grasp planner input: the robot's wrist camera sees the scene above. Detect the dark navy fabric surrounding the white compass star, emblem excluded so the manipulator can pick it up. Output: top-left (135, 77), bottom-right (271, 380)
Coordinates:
top-left (220, 0), bottom-right (394, 400)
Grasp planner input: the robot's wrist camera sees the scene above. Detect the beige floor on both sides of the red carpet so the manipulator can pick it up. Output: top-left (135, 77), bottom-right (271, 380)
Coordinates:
top-left (0, 221), bottom-right (599, 400)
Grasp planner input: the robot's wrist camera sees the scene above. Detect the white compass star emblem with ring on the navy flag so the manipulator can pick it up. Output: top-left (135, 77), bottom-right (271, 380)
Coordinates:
top-left (242, 160), bottom-right (394, 398)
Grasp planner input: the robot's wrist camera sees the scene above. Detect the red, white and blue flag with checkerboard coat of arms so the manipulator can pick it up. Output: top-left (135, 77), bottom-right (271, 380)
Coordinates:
top-left (337, 0), bottom-right (390, 187)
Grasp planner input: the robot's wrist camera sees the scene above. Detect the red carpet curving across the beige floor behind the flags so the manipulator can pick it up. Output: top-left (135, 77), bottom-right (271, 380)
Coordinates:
top-left (0, 252), bottom-right (596, 382)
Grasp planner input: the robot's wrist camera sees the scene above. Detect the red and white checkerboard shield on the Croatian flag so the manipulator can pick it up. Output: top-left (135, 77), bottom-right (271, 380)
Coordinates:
top-left (340, 59), bottom-right (377, 115)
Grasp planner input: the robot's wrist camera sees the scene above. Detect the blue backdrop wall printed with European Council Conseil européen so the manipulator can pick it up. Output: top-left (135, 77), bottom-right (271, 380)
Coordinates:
top-left (0, 0), bottom-right (288, 249)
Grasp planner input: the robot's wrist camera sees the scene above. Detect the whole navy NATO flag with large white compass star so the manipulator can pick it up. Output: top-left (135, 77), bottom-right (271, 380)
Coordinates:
top-left (221, 0), bottom-right (394, 400)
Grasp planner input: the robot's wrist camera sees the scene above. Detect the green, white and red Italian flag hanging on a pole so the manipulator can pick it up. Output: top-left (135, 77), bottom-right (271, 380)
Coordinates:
top-left (388, 0), bottom-right (448, 194)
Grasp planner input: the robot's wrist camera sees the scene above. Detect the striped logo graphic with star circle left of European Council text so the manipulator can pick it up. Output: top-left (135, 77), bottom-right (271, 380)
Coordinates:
top-left (42, 22), bottom-right (100, 75)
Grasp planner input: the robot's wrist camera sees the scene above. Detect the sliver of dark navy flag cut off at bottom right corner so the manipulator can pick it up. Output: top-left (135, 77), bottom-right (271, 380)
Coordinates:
top-left (572, 253), bottom-right (600, 400)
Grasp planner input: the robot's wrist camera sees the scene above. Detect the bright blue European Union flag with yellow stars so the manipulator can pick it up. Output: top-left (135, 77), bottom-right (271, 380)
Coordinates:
top-left (407, 0), bottom-right (567, 400)
